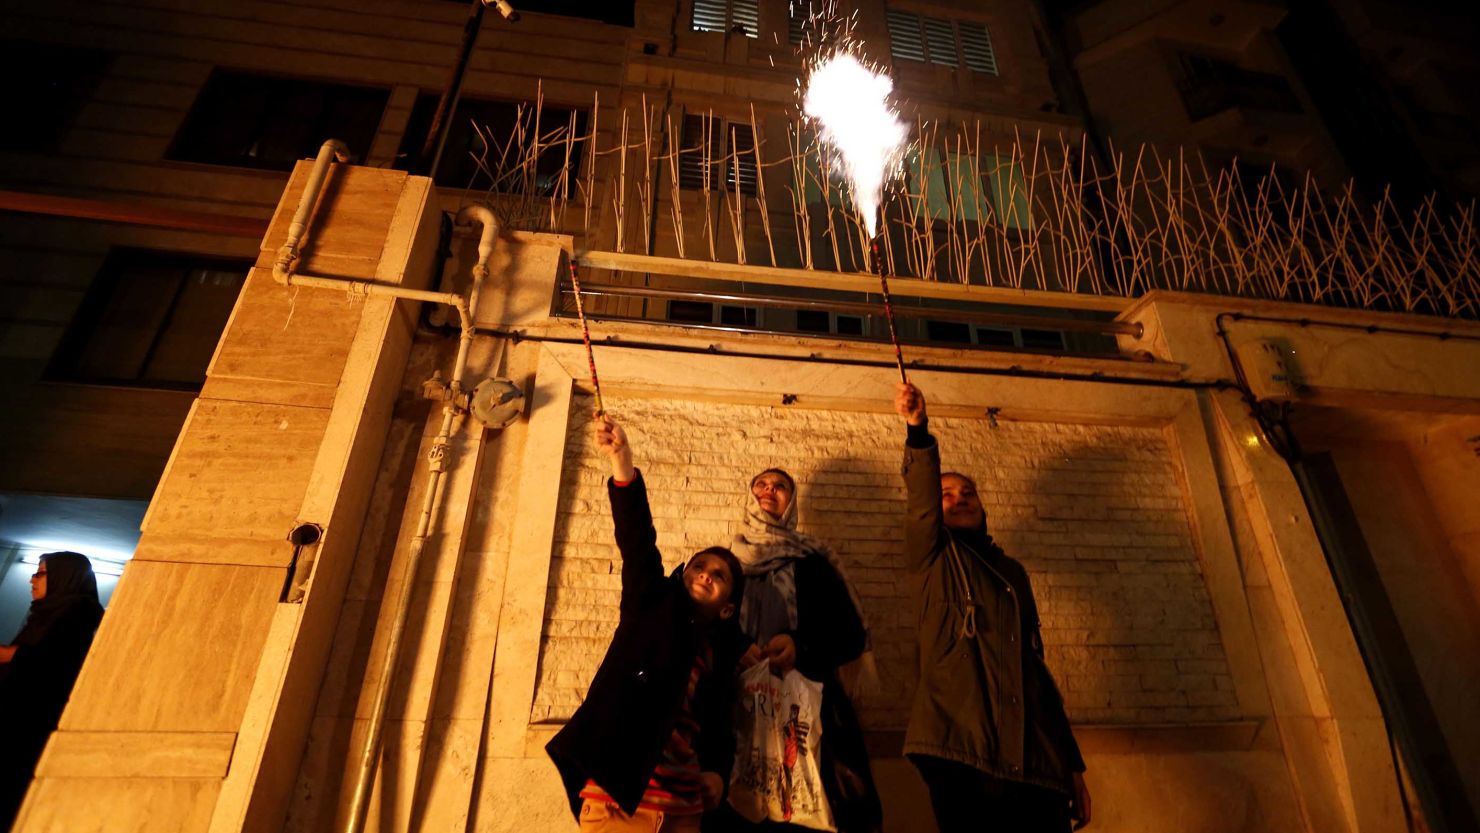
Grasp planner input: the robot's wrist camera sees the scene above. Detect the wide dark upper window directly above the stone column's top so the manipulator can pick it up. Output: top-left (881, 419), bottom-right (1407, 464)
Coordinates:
top-left (166, 70), bottom-right (389, 170)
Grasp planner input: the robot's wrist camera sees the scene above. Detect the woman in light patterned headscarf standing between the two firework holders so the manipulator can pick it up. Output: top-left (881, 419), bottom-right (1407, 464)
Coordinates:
top-left (718, 469), bottom-right (884, 833)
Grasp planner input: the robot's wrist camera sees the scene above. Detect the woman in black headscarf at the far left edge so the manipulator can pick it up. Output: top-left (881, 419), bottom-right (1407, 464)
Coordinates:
top-left (0, 552), bottom-right (102, 830)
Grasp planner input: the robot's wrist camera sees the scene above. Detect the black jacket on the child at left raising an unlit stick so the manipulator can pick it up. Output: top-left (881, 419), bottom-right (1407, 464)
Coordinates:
top-left (545, 472), bottom-right (749, 818)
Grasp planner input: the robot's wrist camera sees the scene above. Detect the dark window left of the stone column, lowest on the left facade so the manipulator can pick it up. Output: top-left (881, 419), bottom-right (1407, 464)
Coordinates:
top-left (47, 249), bottom-right (252, 391)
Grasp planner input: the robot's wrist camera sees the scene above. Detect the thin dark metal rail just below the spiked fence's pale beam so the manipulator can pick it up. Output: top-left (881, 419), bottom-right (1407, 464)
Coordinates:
top-left (559, 281), bottom-right (1143, 339)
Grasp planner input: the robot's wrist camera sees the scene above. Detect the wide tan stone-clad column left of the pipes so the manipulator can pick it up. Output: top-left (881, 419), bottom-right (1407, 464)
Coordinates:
top-left (16, 163), bottom-right (438, 832)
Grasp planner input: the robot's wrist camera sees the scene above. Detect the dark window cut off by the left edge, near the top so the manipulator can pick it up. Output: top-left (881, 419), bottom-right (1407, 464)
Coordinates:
top-left (0, 40), bottom-right (112, 154)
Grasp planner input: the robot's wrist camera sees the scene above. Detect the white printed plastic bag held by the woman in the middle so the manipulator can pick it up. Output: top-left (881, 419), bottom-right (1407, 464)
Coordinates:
top-left (730, 663), bottom-right (836, 830)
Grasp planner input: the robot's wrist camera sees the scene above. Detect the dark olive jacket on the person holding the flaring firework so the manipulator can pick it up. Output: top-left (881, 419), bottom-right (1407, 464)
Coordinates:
top-left (904, 426), bottom-right (1085, 792)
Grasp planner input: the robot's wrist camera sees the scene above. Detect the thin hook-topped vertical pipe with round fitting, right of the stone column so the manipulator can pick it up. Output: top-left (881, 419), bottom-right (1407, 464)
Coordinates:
top-left (335, 206), bottom-right (499, 833)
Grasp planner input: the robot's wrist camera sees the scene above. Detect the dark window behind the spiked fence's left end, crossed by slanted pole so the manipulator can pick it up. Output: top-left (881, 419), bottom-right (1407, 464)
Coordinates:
top-left (397, 93), bottom-right (589, 195)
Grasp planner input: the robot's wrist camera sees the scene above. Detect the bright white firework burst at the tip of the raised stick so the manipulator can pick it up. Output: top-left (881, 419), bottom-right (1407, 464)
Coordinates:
top-left (802, 49), bottom-right (909, 237)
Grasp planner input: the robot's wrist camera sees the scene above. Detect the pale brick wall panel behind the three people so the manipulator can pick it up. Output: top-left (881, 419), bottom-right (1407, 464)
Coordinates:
top-left (531, 397), bottom-right (1237, 729)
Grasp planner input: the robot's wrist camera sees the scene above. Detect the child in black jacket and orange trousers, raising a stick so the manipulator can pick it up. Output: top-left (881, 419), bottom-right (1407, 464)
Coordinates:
top-left (545, 416), bottom-right (749, 833)
